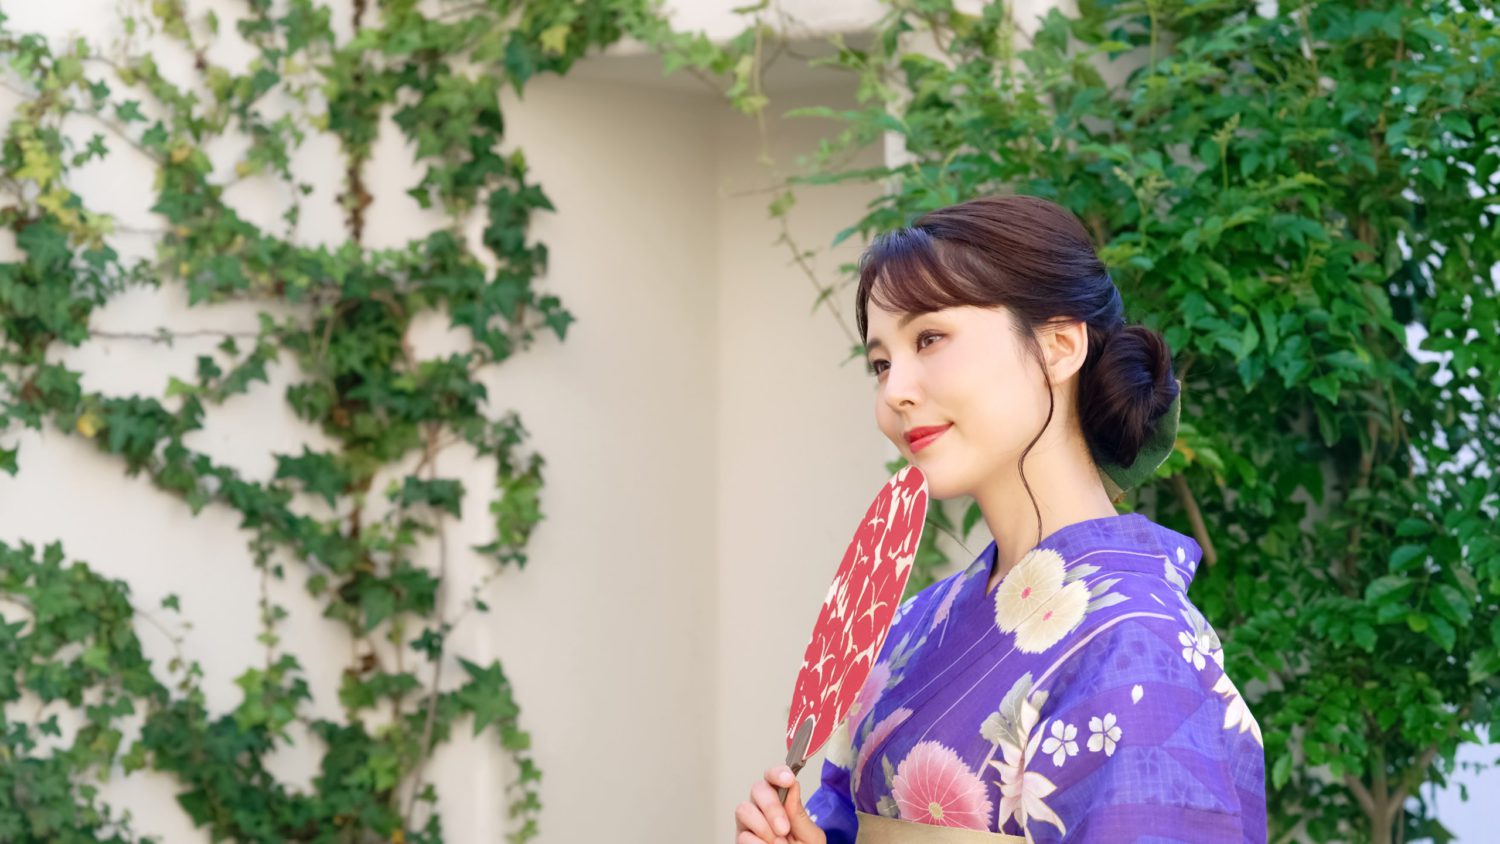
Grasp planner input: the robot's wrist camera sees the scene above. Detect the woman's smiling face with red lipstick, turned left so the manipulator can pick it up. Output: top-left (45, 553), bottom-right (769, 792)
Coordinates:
top-left (866, 303), bottom-right (1061, 499)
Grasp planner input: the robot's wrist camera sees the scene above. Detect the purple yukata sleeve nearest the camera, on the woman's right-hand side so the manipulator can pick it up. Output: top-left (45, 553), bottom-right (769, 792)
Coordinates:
top-left (1017, 618), bottom-right (1266, 844)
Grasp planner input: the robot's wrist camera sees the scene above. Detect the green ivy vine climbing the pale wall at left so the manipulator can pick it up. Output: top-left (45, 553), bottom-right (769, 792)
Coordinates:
top-left (0, 0), bottom-right (672, 843)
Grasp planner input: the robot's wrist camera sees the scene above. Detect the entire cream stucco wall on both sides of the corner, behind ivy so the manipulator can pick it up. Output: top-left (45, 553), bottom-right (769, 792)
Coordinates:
top-left (0, 0), bottom-right (884, 844)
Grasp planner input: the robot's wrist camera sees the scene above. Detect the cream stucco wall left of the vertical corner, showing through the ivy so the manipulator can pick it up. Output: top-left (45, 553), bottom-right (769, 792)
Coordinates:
top-left (0, 1), bottom-right (726, 844)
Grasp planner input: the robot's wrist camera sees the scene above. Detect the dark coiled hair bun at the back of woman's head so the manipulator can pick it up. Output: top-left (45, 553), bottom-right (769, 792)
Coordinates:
top-left (1079, 325), bottom-right (1178, 466)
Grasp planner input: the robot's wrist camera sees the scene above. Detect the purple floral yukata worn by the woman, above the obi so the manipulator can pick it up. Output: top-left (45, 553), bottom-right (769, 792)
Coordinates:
top-left (807, 513), bottom-right (1266, 844)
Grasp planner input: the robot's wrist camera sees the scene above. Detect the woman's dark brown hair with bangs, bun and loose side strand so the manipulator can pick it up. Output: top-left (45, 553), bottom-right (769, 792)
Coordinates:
top-left (855, 196), bottom-right (1178, 541)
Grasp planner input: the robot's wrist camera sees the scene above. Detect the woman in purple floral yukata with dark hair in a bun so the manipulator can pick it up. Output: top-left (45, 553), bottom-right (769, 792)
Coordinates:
top-left (735, 196), bottom-right (1266, 844)
